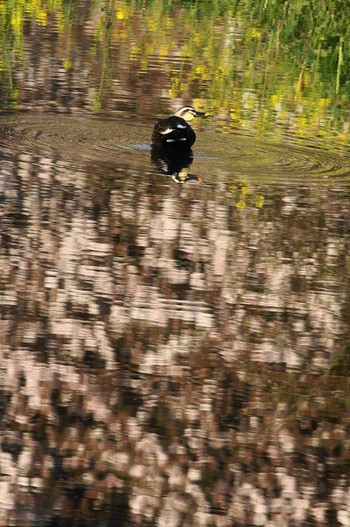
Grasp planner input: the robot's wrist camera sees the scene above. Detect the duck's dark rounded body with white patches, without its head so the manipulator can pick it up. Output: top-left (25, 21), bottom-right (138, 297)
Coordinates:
top-left (152, 115), bottom-right (196, 150)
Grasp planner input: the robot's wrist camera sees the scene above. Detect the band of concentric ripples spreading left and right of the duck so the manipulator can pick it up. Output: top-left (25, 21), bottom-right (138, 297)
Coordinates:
top-left (0, 113), bottom-right (350, 183)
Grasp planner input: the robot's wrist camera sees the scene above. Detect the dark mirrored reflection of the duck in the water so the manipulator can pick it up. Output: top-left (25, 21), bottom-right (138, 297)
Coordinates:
top-left (151, 145), bottom-right (202, 183)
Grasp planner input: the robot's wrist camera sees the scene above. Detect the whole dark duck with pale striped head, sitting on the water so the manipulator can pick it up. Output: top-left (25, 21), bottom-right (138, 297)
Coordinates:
top-left (152, 106), bottom-right (209, 150)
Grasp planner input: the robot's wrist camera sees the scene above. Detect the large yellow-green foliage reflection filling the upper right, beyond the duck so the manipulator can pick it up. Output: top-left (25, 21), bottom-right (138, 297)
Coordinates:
top-left (91, 0), bottom-right (350, 141)
